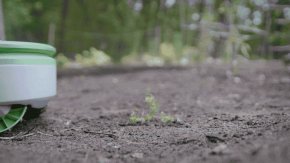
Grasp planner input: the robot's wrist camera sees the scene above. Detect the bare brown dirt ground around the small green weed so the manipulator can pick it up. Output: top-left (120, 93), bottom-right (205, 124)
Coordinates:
top-left (0, 61), bottom-right (290, 163)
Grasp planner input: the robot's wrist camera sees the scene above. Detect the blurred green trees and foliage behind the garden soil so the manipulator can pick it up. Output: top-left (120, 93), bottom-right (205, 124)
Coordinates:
top-left (1, 0), bottom-right (290, 67)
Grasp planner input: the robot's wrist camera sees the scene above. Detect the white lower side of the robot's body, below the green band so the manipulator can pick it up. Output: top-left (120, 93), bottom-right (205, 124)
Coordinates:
top-left (0, 56), bottom-right (56, 108)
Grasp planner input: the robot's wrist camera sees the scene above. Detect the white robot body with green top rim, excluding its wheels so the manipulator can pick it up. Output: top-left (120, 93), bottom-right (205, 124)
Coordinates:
top-left (0, 41), bottom-right (56, 108)
